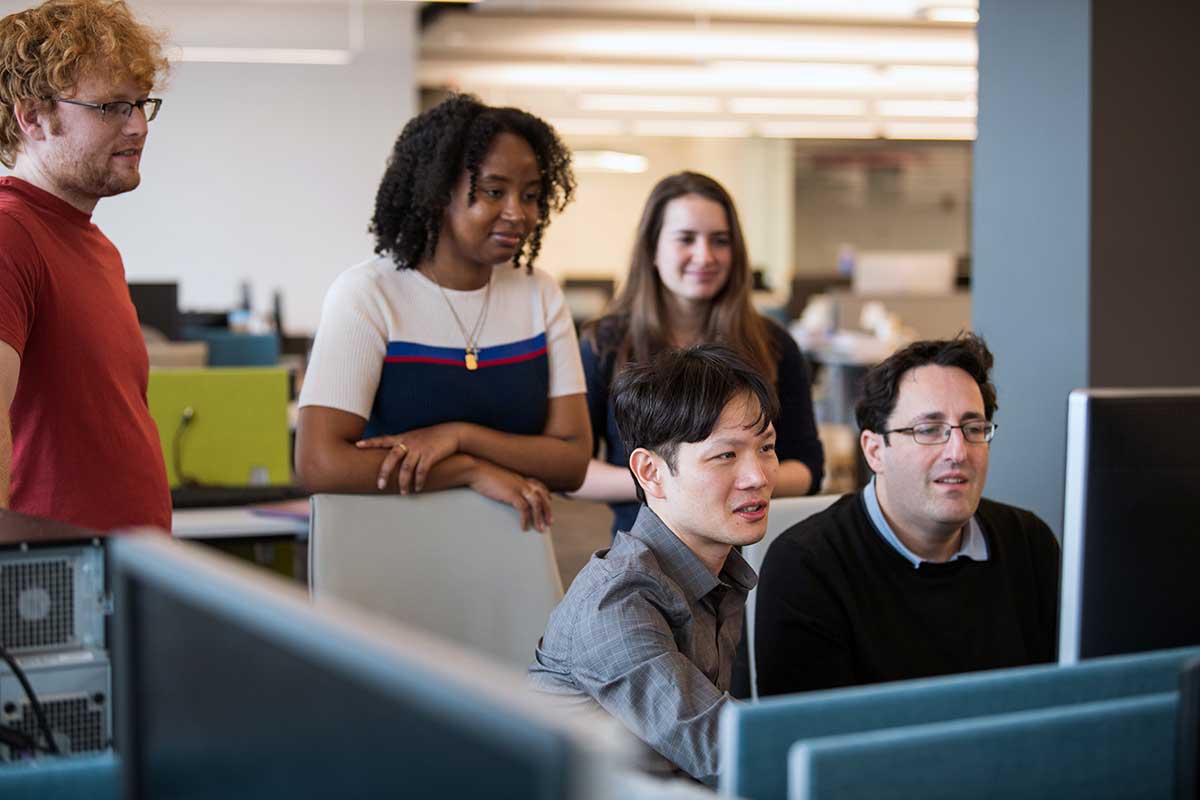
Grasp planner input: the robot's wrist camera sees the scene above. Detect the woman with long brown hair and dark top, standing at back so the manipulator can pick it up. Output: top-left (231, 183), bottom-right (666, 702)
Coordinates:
top-left (576, 172), bottom-right (824, 531)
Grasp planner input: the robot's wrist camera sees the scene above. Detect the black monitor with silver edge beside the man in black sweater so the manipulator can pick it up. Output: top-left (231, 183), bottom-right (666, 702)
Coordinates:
top-left (1058, 389), bottom-right (1200, 663)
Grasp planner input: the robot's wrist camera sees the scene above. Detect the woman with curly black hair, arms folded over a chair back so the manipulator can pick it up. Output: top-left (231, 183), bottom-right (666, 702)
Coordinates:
top-left (296, 95), bottom-right (592, 530)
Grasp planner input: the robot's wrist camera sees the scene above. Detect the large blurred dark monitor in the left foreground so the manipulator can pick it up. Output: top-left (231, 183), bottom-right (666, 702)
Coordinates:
top-left (109, 535), bottom-right (624, 800)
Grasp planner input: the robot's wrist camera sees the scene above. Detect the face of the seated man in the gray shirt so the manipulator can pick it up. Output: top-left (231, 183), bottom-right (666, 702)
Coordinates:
top-left (635, 393), bottom-right (779, 561)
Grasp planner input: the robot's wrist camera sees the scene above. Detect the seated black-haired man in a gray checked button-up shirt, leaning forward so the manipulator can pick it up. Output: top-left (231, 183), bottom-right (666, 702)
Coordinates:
top-left (529, 345), bottom-right (779, 783)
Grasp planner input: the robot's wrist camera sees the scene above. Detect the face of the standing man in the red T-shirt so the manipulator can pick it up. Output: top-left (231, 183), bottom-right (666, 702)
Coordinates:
top-left (28, 71), bottom-right (149, 212)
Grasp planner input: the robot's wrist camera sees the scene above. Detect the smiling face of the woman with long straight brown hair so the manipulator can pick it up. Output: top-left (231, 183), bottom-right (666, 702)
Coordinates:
top-left (654, 194), bottom-right (733, 305)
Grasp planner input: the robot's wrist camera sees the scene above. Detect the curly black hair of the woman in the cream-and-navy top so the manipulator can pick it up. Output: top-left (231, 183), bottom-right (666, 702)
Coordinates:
top-left (370, 94), bottom-right (575, 271)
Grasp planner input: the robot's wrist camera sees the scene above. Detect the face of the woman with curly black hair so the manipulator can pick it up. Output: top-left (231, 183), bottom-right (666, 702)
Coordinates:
top-left (434, 133), bottom-right (541, 280)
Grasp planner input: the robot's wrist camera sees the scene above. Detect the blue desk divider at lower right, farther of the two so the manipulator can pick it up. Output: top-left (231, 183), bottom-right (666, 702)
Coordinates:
top-left (720, 648), bottom-right (1200, 800)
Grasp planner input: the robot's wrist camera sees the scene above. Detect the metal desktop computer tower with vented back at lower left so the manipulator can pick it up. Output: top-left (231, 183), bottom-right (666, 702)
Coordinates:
top-left (0, 522), bottom-right (113, 762)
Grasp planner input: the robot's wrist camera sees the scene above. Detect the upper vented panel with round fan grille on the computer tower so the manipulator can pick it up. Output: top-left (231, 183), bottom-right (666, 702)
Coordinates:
top-left (0, 546), bottom-right (108, 655)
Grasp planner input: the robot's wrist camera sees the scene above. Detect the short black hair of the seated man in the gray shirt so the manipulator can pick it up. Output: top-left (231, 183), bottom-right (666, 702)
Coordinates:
top-left (612, 344), bottom-right (779, 503)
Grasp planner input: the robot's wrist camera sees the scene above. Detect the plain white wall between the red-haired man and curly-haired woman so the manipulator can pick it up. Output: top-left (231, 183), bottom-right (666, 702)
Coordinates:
top-left (0, 0), bottom-right (416, 331)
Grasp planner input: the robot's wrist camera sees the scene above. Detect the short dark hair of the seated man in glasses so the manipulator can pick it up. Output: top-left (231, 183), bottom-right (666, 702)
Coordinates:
top-left (854, 333), bottom-right (996, 441)
